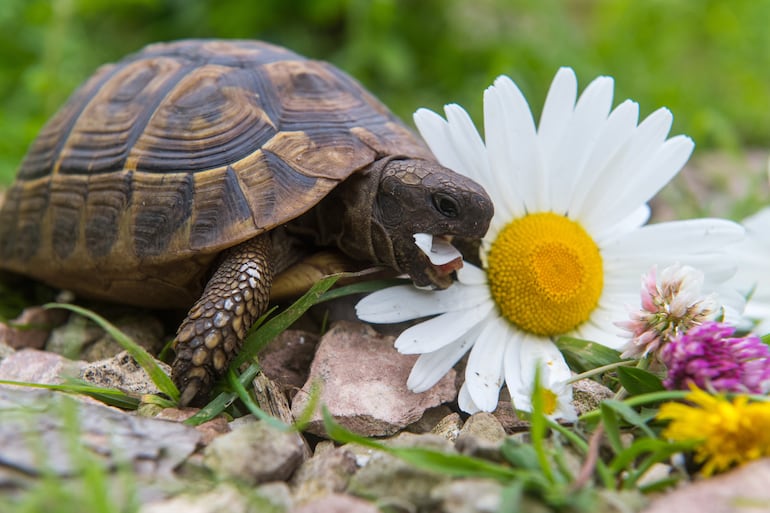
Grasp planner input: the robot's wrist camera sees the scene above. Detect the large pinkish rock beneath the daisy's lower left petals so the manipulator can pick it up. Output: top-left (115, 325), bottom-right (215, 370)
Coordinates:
top-left (292, 321), bottom-right (457, 436)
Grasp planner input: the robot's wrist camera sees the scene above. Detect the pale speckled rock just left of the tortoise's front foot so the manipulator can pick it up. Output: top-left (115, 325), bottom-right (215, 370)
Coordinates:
top-left (80, 351), bottom-right (171, 395)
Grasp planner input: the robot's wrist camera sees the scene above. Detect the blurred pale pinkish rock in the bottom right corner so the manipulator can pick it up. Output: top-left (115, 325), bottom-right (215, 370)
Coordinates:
top-left (644, 458), bottom-right (770, 513)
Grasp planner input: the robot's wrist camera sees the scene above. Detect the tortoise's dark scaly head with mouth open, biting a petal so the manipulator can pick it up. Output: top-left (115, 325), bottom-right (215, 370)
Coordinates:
top-left (372, 159), bottom-right (494, 289)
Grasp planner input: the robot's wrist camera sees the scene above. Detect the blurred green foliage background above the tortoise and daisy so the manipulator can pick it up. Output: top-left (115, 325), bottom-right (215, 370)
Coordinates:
top-left (0, 0), bottom-right (770, 188)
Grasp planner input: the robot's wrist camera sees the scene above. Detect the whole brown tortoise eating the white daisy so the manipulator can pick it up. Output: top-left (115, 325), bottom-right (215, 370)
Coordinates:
top-left (0, 39), bottom-right (493, 404)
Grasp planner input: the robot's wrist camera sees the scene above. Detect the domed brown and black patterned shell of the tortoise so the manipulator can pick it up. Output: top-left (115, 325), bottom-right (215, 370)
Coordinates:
top-left (0, 40), bottom-right (433, 307)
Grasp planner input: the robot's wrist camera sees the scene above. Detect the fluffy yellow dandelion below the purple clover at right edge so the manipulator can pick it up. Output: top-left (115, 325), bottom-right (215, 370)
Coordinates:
top-left (658, 387), bottom-right (770, 476)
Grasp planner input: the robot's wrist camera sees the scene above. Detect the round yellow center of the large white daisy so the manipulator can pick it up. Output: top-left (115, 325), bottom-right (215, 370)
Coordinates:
top-left (487, 212), bottom-right (604, 336)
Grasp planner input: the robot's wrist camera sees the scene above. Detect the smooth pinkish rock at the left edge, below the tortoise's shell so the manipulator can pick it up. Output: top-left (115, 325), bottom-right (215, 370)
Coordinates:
top-left (0, 349), bottom-right (85, 385)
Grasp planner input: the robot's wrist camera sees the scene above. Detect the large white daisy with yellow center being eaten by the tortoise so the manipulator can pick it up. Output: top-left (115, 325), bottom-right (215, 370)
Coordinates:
top-left (357, 68), bottom-right (743, 418)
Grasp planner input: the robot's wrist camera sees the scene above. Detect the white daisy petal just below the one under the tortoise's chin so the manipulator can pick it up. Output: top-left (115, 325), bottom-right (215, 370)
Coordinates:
top-left (395, 300), bottom-right (494, 354)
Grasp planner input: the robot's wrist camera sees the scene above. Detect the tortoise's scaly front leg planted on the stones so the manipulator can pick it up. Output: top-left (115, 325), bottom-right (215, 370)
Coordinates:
top-left (171, 234), bottom-right (273, 406)
